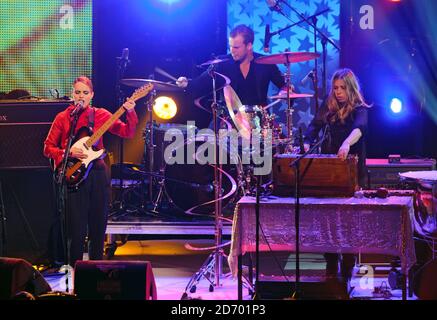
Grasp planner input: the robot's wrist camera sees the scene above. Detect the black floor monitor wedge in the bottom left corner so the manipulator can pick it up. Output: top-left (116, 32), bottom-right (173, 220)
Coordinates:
top-left (0, 258), bottom-right (52, 300)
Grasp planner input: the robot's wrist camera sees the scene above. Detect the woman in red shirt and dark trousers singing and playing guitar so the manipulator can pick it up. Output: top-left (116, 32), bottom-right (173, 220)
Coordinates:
top-left (44, 76), bottom-right (138, 267)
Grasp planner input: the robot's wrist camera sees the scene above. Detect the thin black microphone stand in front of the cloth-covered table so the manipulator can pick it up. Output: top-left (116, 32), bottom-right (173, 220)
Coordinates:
top-left (289, 125), bottom-right (329, 300)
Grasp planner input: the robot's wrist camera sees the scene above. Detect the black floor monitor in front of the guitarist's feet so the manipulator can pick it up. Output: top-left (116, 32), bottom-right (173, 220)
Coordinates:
top-left (74, 260), bottom-right (157, 300)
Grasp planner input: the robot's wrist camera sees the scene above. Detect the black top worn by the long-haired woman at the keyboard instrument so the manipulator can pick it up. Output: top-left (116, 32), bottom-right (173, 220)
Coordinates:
top-left (305, 101), bottom-right (368, 187)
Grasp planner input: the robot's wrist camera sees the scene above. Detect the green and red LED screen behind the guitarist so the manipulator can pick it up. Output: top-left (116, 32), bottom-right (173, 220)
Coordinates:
top-left (0, 0), bottom-right (92, 98)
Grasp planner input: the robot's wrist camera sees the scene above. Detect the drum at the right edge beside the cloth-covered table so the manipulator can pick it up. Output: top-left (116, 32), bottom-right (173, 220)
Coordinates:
top-left (399, 170), bottom-right (437, 239)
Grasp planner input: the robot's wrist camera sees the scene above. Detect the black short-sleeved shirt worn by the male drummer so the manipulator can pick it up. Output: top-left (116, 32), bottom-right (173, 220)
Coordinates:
top-left (187, 53), bottom-right (285, 105)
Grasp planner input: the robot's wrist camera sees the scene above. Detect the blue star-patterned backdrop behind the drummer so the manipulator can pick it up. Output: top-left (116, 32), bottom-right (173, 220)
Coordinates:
top-left (228, 0), bottom-right (340, 128)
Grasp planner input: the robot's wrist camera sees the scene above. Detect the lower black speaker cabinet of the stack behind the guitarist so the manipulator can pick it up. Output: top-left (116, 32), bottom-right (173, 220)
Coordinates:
top-left (0, 168), bottom-right (57, 264)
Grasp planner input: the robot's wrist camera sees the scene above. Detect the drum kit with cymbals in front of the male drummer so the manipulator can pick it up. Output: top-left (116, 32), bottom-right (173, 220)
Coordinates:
top-left (116, 52), bottom-right (319, 214)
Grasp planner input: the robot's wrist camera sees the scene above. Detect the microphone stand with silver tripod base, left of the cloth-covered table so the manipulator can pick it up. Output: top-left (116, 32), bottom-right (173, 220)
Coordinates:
top-left (181, 64), bottom-right (224, 300)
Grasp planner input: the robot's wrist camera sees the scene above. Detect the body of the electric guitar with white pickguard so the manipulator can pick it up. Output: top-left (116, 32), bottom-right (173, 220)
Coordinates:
top-left (65, 127), bottom-right (105, 188)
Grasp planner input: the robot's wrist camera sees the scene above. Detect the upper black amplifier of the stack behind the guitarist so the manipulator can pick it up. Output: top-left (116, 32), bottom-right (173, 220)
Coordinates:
top-left (0, 100), bottom-right (70, 169)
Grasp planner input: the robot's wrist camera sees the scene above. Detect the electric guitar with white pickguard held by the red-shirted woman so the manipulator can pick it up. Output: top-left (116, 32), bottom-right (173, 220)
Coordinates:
top-left (59, 83), bottom-right (153, 188)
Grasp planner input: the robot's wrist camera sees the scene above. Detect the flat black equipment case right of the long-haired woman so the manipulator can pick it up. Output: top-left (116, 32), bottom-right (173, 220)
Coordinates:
top-left (366, 159), bottom-right (436, 189)
